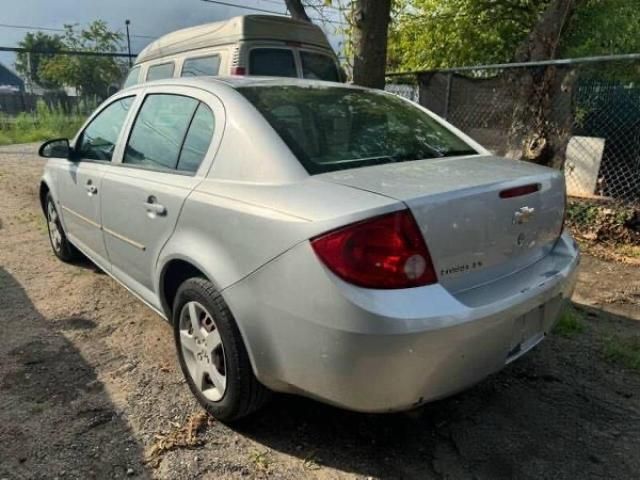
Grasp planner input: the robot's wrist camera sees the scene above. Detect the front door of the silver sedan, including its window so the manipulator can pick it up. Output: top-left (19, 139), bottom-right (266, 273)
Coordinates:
top-left (56, 95), bottom-right (135, 268)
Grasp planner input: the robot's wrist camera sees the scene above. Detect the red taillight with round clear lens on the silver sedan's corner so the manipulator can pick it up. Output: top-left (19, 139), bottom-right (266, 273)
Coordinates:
top-left (311, 210), bottom-right (438, 289)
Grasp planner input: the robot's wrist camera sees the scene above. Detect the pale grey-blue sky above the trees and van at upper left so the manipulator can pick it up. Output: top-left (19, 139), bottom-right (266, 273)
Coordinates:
top-left (0, 0), bottom-right (338, 69)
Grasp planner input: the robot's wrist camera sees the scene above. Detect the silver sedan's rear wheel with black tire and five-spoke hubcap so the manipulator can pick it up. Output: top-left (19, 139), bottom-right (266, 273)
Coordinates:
top-left (172, 278), bottom-right (270, 422)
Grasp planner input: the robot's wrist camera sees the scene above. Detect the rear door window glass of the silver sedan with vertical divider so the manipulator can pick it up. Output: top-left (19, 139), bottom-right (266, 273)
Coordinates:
top-left (123, 94), bottom-right (214, 172)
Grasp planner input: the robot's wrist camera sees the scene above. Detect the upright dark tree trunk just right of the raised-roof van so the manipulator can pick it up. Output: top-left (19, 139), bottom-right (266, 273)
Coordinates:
top-left (353, 0), bottom-right (391, 88)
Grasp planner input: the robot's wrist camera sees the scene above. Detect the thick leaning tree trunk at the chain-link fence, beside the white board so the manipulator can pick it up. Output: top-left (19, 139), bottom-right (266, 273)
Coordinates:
top-left (510, 0), bottom-right (583, 166)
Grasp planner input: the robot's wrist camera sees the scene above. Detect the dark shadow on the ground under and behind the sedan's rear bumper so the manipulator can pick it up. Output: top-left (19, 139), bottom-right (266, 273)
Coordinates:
top-left (239, 307), bottom-right (640, 479)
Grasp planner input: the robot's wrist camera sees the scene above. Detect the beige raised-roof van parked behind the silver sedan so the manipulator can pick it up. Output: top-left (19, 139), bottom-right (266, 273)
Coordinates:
top-left (124, 15), bottom-right (343, 87)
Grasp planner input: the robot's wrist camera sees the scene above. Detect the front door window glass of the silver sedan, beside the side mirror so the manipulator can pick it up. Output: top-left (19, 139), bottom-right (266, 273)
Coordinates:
top-left (76, 97), bottom-right (134, 162)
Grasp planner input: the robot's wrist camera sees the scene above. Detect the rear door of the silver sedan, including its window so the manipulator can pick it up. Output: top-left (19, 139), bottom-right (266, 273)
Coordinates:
top-left (102, 87), bottom-right (224, 308)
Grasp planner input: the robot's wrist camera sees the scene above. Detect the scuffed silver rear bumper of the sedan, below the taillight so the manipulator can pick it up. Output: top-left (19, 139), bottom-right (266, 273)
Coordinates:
top-left (223, 233), bottom-right (579, 412)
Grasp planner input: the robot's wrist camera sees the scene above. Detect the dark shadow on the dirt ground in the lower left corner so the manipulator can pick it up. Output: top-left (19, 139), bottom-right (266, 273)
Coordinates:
top-left (0, 267), bottom-right (147, 479)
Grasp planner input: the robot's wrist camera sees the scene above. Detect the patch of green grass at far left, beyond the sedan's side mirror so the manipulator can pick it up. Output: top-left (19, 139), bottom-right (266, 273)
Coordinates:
top-left (0, 102), bottom-right (91, 145)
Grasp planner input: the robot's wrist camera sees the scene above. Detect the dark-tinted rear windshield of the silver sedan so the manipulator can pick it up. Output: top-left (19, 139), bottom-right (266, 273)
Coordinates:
top-left (238, 85), bottom-right (477, 175)
